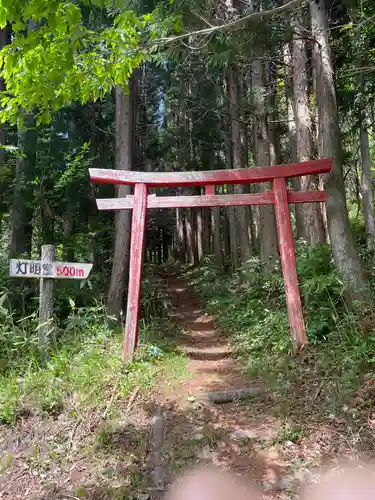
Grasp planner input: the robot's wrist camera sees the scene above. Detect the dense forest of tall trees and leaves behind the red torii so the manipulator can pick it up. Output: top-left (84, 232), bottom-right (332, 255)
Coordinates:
top-left (1, 0), bottom-right (375, 308)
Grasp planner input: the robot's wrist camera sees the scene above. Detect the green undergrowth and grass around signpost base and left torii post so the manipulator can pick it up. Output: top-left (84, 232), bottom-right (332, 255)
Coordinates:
top-left (0, 285), bottom-right (186, 424)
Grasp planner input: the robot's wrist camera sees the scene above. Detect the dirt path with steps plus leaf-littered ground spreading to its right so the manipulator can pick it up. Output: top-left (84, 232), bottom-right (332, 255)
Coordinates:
top-left (148, 277), bottom-right (372, 500)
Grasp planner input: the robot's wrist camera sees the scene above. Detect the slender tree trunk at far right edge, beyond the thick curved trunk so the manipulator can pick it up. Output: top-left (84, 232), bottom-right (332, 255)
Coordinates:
top-left (359, 110), bottom-right (375, 251)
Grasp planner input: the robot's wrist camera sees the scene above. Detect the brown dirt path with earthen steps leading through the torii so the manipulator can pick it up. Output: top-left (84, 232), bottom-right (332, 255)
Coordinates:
top-left (154, 277), bottom-right (287, 498)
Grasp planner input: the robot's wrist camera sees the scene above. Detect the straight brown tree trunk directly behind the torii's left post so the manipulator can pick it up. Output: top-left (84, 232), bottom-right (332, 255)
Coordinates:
top-left (107, 82), bottom-right (134, 318)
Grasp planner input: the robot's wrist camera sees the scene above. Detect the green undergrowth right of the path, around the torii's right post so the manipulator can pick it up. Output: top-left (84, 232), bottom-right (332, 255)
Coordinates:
top-left (187, 243), bottom-right (375, 415)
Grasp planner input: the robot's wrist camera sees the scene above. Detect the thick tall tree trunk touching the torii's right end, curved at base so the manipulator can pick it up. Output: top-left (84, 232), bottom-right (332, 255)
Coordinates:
top-left (309, 0), bottom-right (368, 298)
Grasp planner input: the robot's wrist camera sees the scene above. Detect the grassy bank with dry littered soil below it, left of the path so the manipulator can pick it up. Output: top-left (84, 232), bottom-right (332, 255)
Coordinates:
top-left (0, 280), bottom-right (190, 500)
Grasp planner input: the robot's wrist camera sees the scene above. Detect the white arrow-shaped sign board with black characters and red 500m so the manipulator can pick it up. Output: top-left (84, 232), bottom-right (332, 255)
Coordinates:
top-left (10, 259), bottom-right (92, 280)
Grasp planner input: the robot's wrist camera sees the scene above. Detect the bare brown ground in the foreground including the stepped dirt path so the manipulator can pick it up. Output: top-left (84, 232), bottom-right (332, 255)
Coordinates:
top-left (0, 275), bottom-right (370, 500)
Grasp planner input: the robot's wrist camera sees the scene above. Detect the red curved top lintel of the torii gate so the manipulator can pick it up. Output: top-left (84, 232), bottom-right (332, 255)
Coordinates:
top-left (89, 158), bottom-right (332, 187)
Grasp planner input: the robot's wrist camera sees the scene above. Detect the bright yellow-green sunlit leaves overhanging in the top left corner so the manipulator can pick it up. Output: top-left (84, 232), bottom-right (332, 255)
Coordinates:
top-left (0, 0), bottom-right (187, 123)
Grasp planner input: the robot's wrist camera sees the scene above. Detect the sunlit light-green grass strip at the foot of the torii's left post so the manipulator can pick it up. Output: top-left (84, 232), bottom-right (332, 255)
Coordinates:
top-left (0, 314), bottom-right (186, 424)
